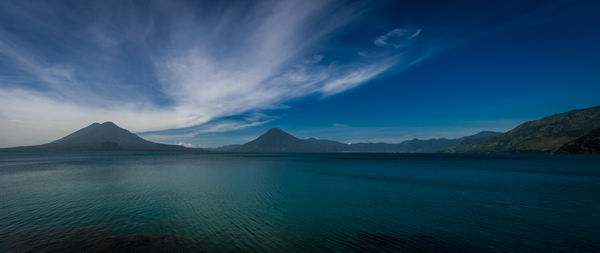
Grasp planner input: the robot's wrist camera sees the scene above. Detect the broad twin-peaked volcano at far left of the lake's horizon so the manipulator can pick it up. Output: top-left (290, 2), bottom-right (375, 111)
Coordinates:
top-left (0, 122), bottom-right (199, 151)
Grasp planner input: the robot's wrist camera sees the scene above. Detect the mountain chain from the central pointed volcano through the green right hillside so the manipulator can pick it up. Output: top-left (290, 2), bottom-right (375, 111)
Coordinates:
top-left (220, 106), bottom-right (600, 153)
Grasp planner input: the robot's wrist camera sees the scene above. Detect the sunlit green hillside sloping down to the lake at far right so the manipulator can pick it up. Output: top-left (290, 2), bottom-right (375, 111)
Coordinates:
top-left (458, 106), bottom-right (600, 153)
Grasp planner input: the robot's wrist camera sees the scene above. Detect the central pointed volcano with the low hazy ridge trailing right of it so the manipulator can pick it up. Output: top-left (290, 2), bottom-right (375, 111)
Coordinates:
top-left (232, 128), bottom-right (501, 153)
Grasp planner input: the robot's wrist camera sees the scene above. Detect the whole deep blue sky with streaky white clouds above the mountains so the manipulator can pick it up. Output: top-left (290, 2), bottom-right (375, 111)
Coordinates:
top-left (0, 0), bottom-right (600, 147)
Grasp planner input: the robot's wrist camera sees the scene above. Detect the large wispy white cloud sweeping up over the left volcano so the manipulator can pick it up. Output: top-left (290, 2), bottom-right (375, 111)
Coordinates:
top-left (0, 0), bottom-right (432, 146)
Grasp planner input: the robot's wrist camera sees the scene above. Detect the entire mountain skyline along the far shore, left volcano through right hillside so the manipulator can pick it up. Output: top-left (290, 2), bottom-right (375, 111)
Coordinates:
top-left (0, 106), bottom-right (600, 154)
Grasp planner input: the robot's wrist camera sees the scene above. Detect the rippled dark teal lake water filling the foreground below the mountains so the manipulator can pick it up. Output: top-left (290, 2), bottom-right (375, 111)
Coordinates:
top-left (0, 153), bottom-right (600, 252)
